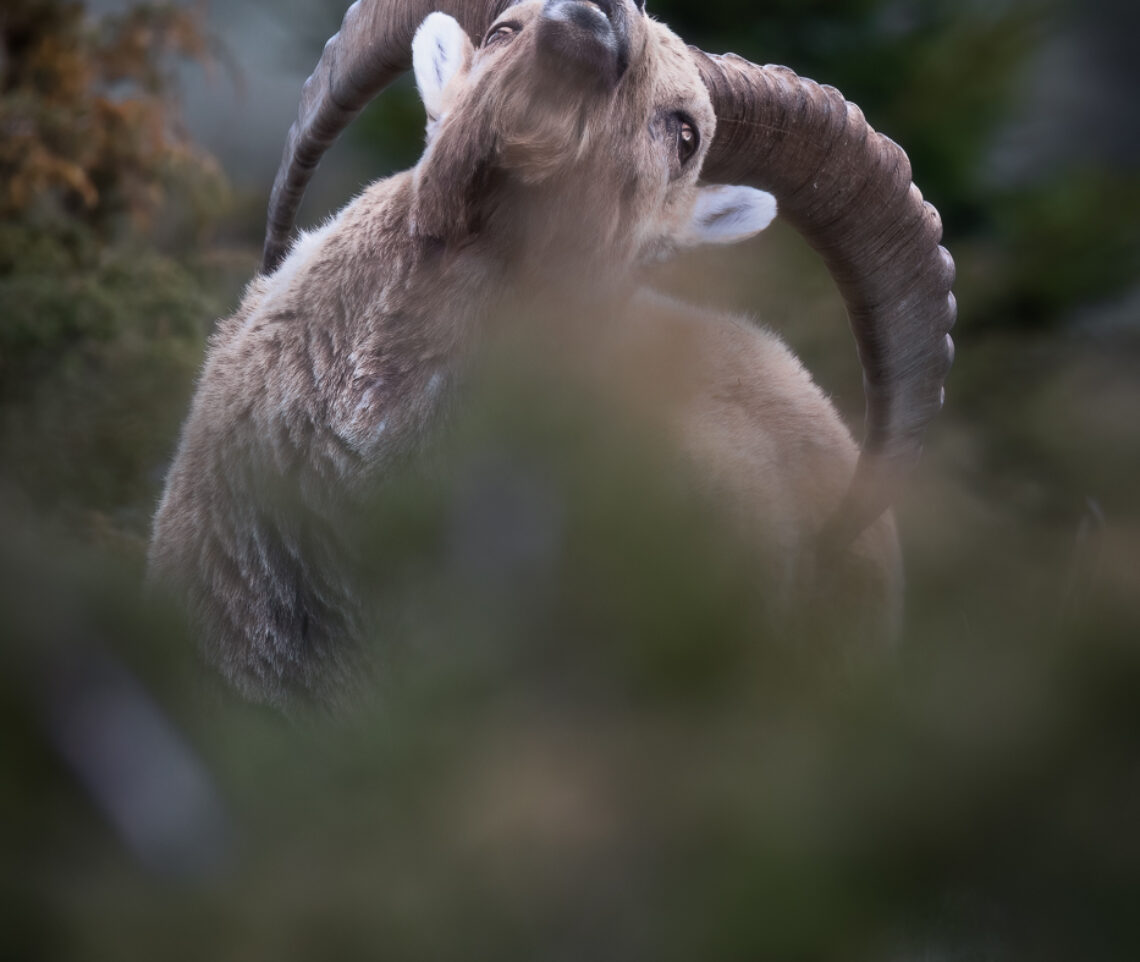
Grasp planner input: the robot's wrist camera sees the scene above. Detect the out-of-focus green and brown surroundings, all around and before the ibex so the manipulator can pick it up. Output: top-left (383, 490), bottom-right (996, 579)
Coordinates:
top-left (0, 0), bottom-right (1140, 960)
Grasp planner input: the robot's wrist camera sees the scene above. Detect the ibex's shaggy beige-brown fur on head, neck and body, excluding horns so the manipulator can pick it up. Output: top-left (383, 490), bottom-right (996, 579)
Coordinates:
top-left (149, 2), bottom-right (899, 706)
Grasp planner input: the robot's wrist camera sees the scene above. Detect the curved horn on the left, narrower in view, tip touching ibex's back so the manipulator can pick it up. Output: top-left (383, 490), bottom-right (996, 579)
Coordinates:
top-left (261, 0), bottom-right (511, 274)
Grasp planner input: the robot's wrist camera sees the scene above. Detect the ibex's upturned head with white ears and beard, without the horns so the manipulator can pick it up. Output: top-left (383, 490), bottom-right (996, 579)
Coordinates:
top-left (413, 0), bottom-right (775, 275)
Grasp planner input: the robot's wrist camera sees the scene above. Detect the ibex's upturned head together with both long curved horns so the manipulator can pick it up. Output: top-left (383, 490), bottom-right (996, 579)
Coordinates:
top-left (262, 0), bottom-right (955, 540)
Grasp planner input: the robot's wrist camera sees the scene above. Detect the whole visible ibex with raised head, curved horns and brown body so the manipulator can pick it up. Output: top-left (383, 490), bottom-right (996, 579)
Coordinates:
top-left (149, 0), bottom-right (955, 704)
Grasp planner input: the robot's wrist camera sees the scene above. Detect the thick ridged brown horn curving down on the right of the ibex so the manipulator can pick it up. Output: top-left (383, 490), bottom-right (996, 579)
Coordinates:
top-left (691, 48), bottom-right (958, 546)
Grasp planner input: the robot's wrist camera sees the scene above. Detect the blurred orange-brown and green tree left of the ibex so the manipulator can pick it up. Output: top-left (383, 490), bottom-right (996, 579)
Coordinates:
top-left (0, 0), bottom-right (227, 538)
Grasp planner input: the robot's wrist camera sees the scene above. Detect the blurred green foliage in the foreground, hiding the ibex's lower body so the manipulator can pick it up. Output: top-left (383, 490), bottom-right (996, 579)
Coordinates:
top-left (0, 385), bottom-right (1140, 962)
